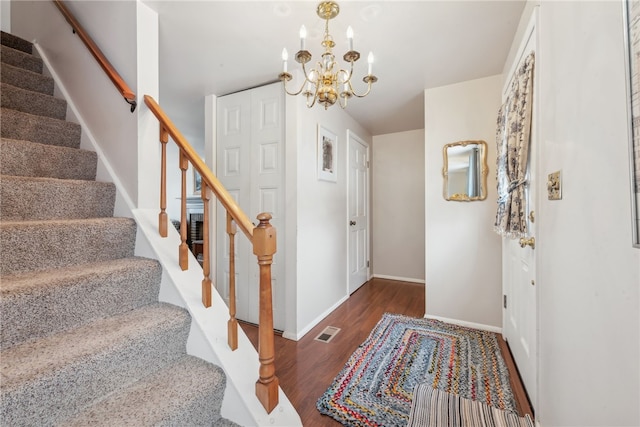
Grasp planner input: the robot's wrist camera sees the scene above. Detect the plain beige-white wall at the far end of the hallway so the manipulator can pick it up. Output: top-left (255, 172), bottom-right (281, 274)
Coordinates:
top-left (371, 129), bottom-right (425, 283)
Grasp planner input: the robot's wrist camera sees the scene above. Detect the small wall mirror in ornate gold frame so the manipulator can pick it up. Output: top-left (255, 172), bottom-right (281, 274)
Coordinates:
top-left (442, 140), bottom-right (489, 202)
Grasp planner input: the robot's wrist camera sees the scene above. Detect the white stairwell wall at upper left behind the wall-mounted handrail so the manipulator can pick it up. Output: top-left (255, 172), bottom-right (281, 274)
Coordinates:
top-left (10, 1), bottom-right (141, 207)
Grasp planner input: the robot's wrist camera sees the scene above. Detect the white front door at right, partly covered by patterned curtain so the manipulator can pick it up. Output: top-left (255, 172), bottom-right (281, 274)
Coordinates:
top-left (502, 13), bottom-right (538, 408)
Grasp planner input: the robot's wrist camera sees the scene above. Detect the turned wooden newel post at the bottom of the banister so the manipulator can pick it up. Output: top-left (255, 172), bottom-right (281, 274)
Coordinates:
top-left (253, 213), bottom-right (279, 413)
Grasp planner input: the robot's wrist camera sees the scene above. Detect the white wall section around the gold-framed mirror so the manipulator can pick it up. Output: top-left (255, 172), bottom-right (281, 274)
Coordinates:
top-left (425, 75), bottom-right (502, 328)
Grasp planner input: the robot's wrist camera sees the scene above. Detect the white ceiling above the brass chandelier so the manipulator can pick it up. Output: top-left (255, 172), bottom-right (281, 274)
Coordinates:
top-left (144, 0), bottom-right (525, 145)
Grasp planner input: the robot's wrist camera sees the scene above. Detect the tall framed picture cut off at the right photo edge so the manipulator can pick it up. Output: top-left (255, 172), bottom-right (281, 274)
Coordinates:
top-left (622, 0), bottom-right (640, 248)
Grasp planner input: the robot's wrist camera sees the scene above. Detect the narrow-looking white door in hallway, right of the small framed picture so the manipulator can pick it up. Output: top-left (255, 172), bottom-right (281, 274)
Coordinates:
top-left (347, 131), bottom-right (369, 294)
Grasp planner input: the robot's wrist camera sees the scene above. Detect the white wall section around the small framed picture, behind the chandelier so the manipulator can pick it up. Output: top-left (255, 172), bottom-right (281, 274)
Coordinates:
top-left (296, 97), bottom-right (371, 336)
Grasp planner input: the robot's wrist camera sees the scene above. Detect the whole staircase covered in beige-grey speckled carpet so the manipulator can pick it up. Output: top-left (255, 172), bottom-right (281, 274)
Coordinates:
top-left (0, 32), bottom-right (235, 426)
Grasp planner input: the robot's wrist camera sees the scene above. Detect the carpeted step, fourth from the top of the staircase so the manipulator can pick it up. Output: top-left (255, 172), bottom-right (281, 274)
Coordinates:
top-left (0, 83), bottom-right (67, 120)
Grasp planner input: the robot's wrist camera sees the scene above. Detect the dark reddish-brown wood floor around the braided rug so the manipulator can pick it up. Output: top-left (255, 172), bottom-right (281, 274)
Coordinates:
top-left (241, 279), bottom-right (531, 427)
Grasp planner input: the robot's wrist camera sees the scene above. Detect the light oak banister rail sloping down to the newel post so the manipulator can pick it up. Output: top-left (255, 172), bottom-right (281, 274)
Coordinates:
top-left (144, 95), bottom-right (253, 241)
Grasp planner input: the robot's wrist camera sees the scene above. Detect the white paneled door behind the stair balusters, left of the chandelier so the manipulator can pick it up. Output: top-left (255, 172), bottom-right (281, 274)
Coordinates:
top-left (216, 84), bottom-right (285, 330)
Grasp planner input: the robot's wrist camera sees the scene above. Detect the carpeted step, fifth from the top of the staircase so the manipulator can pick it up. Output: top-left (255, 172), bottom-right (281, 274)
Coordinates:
top-left (0, 108), bottom-right (82, 148)
